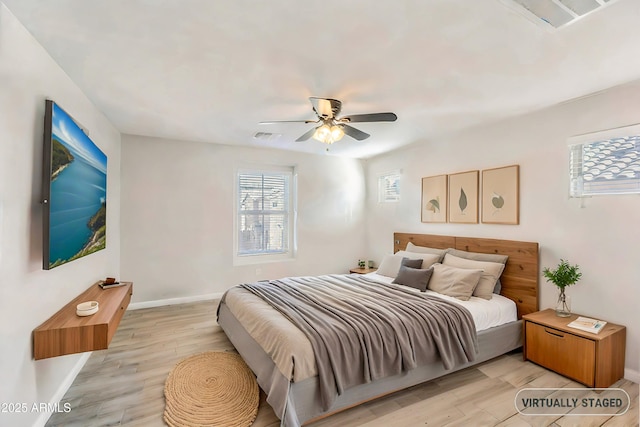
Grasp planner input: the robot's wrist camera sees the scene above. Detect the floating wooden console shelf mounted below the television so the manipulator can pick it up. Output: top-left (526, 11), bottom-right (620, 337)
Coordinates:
top-left (33, 282), bottom-right (133, 360)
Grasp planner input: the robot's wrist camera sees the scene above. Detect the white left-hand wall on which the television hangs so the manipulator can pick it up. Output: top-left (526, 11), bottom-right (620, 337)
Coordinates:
top-left (0, 3), bottom-right (120, 426)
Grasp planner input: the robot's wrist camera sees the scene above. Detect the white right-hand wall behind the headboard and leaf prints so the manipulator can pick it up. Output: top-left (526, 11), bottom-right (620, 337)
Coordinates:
top-left (366, 82), bottom-right (640, 381)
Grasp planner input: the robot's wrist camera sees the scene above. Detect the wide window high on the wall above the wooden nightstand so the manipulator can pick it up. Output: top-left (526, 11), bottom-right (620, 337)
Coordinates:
top-left (569, 126), bottom-right (640, 197)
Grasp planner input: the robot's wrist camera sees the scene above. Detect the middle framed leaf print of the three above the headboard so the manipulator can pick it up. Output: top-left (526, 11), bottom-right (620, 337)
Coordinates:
top-left (449, 171), bottom-right (480, 224)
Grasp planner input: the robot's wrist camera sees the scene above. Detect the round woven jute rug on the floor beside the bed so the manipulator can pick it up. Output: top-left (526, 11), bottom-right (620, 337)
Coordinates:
top-left (164, 351), bottom-right (260, 427)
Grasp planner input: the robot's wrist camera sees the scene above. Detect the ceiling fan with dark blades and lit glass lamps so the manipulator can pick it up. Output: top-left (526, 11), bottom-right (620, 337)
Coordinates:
top-left (260, 96), bottom-right (398, 144)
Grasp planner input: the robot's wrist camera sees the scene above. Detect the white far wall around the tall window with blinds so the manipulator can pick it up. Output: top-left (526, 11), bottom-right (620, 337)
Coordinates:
top-left (122, 135), bottom-right (366, 304)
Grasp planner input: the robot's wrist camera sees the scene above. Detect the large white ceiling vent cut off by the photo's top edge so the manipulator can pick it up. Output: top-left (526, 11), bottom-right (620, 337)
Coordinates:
top-left (500, 0), bottom-right (615, 30)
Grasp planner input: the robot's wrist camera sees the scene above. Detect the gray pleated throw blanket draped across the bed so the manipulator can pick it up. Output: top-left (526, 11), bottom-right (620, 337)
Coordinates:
top-left (240, 275), bottom-right (478, 410)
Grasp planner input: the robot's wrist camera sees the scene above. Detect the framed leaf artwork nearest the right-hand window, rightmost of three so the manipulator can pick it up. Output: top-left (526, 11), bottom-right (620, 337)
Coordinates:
top-left (482, 165), bottom-right (520, 224)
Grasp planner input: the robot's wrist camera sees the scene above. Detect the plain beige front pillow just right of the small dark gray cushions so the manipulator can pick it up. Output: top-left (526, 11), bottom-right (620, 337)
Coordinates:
top-left (428, 264), bottom-right (482, 301)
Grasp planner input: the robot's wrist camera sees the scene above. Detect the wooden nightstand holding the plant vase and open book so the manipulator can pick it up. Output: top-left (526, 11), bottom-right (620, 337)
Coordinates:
top-left (522, 309), bottom-right (626, 388)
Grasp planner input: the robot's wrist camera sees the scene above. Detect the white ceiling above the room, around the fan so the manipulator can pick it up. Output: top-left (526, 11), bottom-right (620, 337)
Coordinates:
top-left (1, 0), bottom-right (640, 158)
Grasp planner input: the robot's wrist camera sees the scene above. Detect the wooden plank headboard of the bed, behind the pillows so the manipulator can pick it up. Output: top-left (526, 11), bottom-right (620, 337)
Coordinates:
top-left (393, 233), bottom-right (539, 319)
